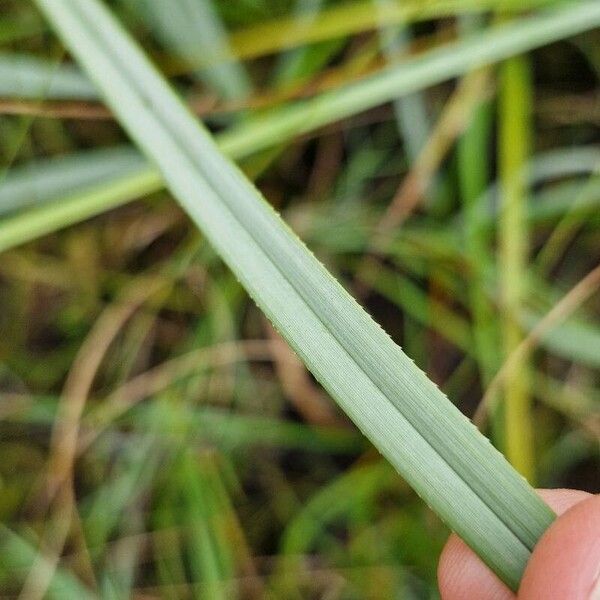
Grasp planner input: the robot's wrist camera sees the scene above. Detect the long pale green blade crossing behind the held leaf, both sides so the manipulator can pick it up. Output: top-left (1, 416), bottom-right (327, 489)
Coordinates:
top-left (0, 2), bottom-right (600, 251)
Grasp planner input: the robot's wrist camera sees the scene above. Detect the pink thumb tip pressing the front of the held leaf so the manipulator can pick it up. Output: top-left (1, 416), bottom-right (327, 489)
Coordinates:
top-left (518, 496), bottom-right (600, 600)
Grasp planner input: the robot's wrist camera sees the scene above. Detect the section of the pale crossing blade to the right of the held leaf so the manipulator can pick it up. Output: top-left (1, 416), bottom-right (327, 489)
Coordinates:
top-left (221, 2), bottom-right (600, 156)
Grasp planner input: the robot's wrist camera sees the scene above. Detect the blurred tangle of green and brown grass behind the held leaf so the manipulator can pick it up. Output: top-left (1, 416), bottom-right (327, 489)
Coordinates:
top-left (0, 0), bottom-right (600, 599)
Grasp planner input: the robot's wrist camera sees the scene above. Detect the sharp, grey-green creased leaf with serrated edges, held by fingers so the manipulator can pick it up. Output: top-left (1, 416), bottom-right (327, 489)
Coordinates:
top-left (31, 0), bottom-right (556, 589)
